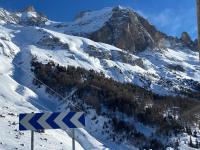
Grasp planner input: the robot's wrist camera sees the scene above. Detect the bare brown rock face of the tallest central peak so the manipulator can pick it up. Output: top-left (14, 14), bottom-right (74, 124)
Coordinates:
top-left (90, 7), bottom-right (166, 52)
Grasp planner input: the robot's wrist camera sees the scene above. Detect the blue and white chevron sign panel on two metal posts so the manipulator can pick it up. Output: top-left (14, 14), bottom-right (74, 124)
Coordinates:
top-left (19, 112), bottom-right (85, 131)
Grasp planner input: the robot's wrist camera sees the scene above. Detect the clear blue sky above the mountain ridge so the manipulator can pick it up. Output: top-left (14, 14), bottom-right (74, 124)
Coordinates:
top-left (0, 0), bottom-right (197, 39)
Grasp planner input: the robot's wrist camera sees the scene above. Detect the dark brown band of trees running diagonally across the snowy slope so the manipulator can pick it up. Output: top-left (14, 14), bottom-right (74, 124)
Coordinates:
top-left (32, 59), bottom-right (200, 149)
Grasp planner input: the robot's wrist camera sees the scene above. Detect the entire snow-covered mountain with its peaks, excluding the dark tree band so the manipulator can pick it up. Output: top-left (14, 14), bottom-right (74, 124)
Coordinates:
top-left (0, 7), bottom-right (200, 149)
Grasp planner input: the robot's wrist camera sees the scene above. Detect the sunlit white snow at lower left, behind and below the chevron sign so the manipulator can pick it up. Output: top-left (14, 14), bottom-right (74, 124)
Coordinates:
top-left (0, 55), bottom-right (83, 150)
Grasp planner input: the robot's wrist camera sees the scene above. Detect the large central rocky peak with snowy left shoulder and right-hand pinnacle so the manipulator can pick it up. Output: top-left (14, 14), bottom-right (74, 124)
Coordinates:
top-left (65, 6), bottom-right (196, 53)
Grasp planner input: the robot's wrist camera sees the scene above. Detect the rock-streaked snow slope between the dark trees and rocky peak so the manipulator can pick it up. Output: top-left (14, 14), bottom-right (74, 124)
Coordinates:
top-left (29, 28), bottom-right (200, 95)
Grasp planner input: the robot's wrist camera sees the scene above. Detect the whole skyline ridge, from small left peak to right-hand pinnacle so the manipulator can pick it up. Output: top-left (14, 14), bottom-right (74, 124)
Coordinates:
top-left (1, 6), bottom-right (197, 53)
